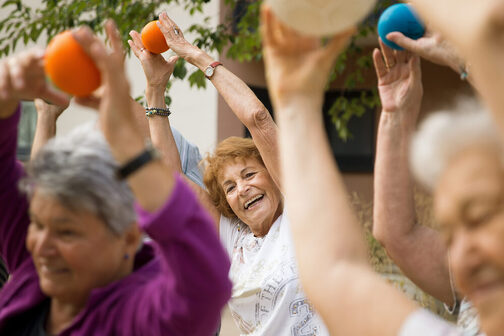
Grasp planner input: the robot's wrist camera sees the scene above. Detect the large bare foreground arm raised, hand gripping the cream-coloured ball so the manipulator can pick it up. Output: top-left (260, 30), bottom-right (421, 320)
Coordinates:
top-left (262, 7), bottom-right (415, 336)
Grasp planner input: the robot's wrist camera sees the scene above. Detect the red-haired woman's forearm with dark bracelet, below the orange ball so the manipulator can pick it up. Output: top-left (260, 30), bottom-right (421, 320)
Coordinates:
top-left (145, 86), bottom-right (182, 173)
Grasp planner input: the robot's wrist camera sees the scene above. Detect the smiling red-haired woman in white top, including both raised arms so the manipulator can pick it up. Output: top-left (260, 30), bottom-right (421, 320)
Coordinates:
top-left (130, 13), bottom-right (328, 335)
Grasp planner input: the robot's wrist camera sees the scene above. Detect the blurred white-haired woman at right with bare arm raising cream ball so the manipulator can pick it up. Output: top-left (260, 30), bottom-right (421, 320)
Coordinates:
top-left (262, 7), bottom-right (504, 336)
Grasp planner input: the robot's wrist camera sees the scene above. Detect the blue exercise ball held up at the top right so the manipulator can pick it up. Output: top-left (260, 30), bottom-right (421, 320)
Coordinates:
top-left (378, 4), bottom-right (425, 50)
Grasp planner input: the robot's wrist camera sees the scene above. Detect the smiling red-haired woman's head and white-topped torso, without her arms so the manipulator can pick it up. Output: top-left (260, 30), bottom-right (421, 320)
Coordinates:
top-left (204, 136), bottom-right (328, 335)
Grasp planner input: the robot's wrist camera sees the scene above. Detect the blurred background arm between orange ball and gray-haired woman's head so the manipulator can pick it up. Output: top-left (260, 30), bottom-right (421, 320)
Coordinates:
top-left (30, 98), bottom-right (68, 158)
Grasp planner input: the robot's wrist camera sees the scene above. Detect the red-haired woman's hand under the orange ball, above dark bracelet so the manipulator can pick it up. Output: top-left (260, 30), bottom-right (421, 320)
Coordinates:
top-left (128, 30), bottom-right (178, 88)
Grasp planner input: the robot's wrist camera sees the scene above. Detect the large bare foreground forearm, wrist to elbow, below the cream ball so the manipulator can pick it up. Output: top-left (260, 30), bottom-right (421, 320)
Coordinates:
top-left (277, 92), bottom-right (367, 281)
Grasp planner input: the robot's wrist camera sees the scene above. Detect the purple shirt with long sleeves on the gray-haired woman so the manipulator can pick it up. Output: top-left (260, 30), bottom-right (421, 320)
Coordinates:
top-left (0, 109), bottom-right (231, 336)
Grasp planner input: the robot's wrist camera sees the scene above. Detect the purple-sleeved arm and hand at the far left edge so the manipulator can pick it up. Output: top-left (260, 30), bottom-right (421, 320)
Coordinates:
top-left (0, 50), bottom-right (68, 272)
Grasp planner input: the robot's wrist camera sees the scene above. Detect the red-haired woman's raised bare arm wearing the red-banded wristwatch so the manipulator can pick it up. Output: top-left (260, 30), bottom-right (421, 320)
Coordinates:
top-left (159, 12), bottom-right (280, 186)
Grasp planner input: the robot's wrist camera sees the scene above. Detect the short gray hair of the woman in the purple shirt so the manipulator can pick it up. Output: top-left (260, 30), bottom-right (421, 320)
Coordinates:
top-left (20, 124), bottom-right (136, 235)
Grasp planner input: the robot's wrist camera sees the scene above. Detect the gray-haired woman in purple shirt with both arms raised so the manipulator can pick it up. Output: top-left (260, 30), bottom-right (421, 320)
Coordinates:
top-left (0, 22), bottom-right (231, 335)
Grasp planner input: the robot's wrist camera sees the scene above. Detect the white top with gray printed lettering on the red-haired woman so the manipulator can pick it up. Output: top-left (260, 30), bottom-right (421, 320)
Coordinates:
top-left (220, 213), bottom-right (329, 336)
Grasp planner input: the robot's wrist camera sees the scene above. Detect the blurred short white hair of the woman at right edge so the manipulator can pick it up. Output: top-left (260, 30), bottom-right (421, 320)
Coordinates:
top-left (410, 99), bottom-right (504, 190)
